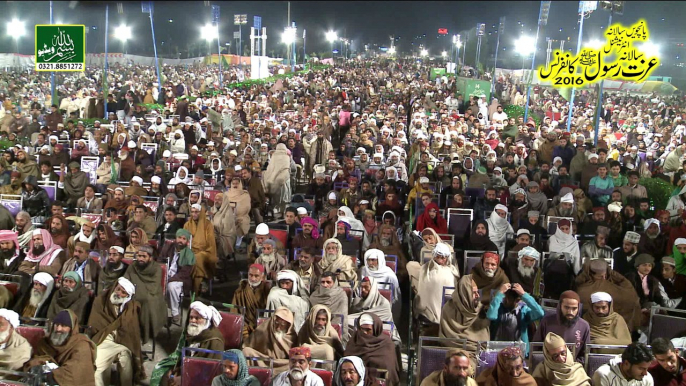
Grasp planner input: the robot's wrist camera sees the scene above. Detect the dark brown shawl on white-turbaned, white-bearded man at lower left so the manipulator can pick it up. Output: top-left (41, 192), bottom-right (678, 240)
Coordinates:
top-left (88, 286), bottom-right (145, 381)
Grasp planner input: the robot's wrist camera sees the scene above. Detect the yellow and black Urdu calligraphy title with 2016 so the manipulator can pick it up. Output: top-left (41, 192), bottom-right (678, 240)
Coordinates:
top-left (537, 20), bottom-right (660, 87)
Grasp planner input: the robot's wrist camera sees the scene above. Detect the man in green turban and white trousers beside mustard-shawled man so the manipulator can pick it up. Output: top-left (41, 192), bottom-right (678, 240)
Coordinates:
top-left (167, 229), bottom-right (195, 324)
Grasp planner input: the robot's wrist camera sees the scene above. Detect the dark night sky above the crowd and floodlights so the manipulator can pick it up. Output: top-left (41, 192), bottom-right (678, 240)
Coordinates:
top-left (0, 1), bottom-right (686, 69)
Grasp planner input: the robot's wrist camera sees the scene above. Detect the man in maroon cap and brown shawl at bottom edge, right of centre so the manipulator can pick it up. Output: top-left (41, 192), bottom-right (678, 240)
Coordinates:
top-left (476, 346), bottom-right (536, 386)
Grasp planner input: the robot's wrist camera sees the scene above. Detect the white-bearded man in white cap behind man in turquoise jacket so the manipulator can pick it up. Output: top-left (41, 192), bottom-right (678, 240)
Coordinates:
top-left (501, 247), bottom-right (543, 300)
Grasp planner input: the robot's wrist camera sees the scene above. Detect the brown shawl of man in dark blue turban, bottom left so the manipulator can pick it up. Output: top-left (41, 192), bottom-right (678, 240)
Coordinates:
top-left (24, 309), bottom-right (96, 386)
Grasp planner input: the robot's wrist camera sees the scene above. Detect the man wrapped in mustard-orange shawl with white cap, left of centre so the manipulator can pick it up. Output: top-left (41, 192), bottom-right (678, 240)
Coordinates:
top-left (183, 204), bottom-right (219, 294)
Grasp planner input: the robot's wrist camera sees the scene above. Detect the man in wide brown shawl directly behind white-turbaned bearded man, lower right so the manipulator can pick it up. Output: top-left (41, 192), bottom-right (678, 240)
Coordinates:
top-left (575, 260), bottom-right (641, 332)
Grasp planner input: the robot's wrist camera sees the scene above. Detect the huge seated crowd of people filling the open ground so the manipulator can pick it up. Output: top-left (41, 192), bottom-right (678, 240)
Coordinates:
top-left (0, 56), bottom-right (686, 386)
